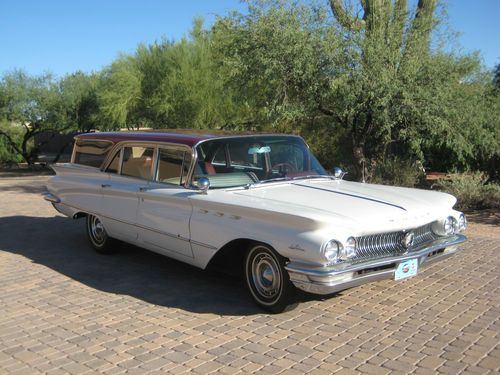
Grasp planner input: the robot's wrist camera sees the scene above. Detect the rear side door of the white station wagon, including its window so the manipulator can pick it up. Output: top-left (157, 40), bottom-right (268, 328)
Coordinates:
top-left (100, 144), bottom-right (155, 242)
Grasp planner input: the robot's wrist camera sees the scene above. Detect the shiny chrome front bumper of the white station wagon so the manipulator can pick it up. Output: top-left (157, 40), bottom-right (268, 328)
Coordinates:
top-left (285, 234), bottom-right (467, 295)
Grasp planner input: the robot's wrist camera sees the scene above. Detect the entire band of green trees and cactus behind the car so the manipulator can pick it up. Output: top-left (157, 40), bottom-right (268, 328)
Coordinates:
top-left (0, 0), bottom-right (500, 186)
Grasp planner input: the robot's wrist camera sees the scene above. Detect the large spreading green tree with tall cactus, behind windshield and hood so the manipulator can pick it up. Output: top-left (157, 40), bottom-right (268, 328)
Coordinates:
top-left (213, 0), bottom-right (497, 178)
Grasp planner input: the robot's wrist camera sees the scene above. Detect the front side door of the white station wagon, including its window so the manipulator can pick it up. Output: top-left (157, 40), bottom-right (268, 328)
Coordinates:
top-left (137, 145), bottom-right (195, 262)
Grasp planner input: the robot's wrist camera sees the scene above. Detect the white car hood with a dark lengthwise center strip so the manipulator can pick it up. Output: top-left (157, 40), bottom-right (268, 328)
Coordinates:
top-left (233, 179), bottom-right (456, 231)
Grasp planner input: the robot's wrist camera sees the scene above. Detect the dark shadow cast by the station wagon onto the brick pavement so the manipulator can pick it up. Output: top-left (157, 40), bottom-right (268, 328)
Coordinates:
top-left (0, 216), bottom-right (262, 315)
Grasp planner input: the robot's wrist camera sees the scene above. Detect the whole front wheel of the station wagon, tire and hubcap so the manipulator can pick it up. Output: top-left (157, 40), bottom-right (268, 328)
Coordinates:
top-left (245, 244), bottom-right (295, 313)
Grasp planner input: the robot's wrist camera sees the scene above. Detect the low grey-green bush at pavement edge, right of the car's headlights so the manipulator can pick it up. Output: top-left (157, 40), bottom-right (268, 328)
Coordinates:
top-left (435, 172), bottom-right (500, 210)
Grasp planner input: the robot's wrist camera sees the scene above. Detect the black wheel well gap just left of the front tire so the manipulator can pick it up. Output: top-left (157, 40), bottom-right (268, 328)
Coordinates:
top-left (207, 238), bottom-right (257, 276)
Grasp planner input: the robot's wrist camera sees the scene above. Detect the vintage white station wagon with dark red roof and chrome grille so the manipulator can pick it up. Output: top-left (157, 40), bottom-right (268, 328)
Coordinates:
top-left (45, 132), bottom-right (467, 312)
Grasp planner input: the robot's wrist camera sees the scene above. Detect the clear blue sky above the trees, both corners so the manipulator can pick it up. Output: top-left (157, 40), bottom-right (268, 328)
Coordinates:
top-left (0, 0), bottom-right (500, 77)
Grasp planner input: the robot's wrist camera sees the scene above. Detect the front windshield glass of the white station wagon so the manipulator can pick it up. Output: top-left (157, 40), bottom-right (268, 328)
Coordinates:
top-left (193, 136), bottom-right (327, 188)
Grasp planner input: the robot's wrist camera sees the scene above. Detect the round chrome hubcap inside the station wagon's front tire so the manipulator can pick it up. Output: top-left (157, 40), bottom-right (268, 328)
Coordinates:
top-left (252, 254), bottom-right (281, 298)
